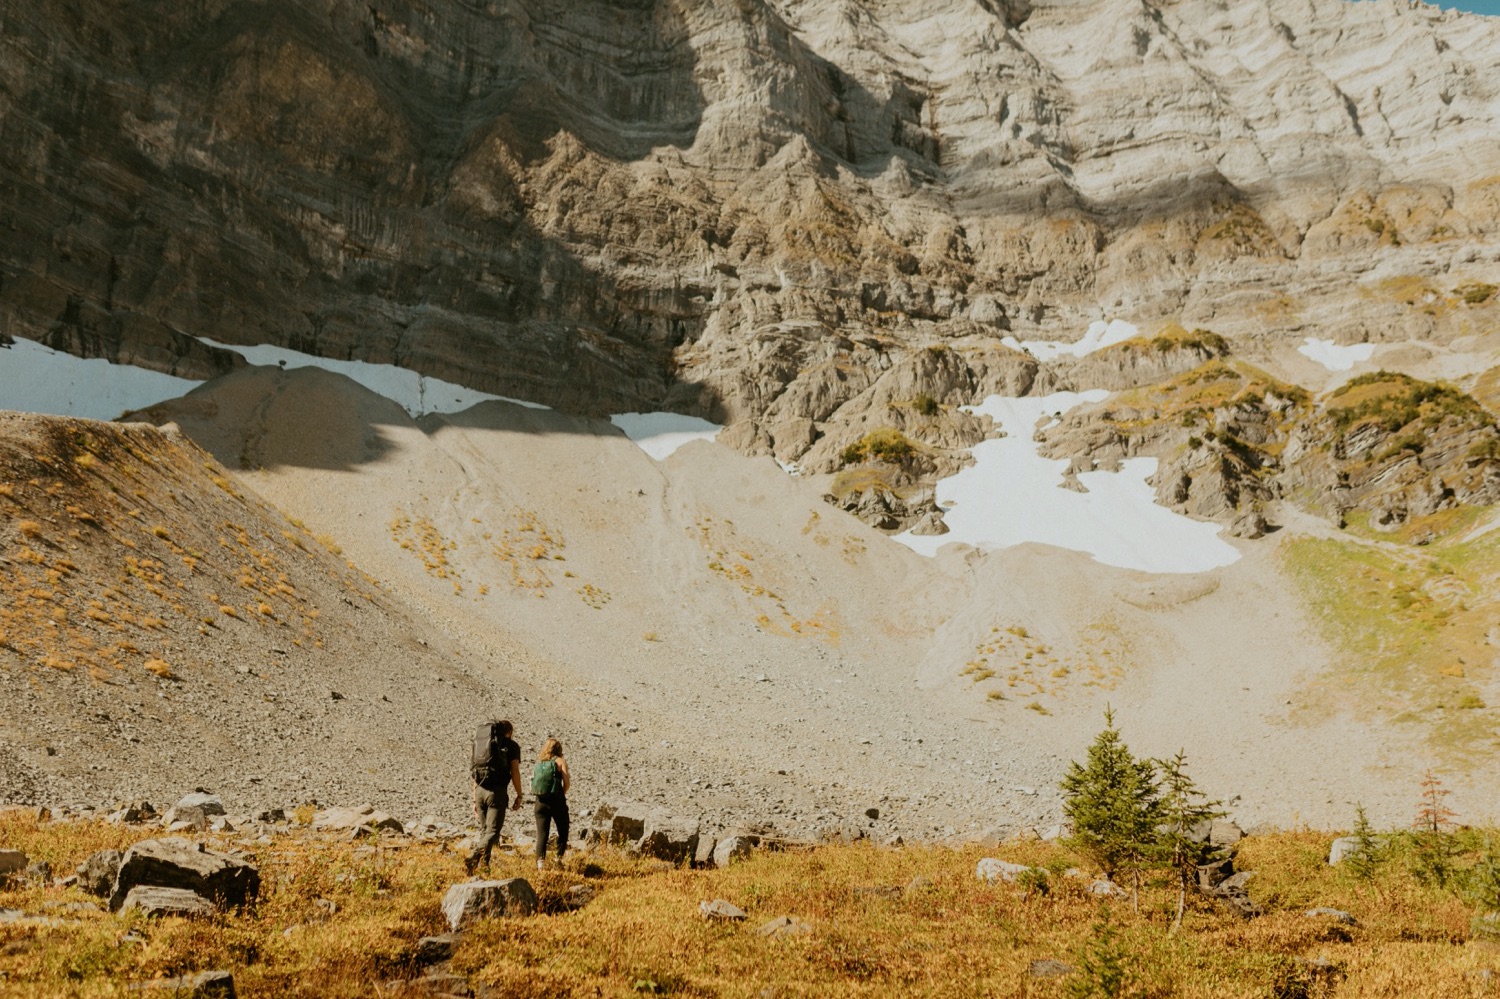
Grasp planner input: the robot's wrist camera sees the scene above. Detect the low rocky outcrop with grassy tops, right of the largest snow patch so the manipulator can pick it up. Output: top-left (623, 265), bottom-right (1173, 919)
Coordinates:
top-left (1043, 360), bottom-right (1500, 537)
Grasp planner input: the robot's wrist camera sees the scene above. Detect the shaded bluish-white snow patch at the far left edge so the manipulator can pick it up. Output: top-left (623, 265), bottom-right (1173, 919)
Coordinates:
top-left (0, 336), bottom-right (200, 420)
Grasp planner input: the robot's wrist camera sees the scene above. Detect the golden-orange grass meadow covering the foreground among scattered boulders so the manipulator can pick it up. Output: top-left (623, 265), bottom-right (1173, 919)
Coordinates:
top-left (0, 818), bottom-right (1500, 999)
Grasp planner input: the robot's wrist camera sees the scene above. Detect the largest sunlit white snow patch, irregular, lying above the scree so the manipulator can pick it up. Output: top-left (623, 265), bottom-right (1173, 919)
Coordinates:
top-left (896, 389), bottom-right (1239, 573)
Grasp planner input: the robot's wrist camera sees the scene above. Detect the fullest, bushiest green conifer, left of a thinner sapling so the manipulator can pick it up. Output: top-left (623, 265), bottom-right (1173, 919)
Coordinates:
top-left (1061, 708), bottom-right (1161, 879)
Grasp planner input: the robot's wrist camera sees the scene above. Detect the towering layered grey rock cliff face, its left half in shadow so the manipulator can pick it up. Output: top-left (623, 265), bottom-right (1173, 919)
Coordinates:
top-left (0, 0), bottom-right (1500, 513)
